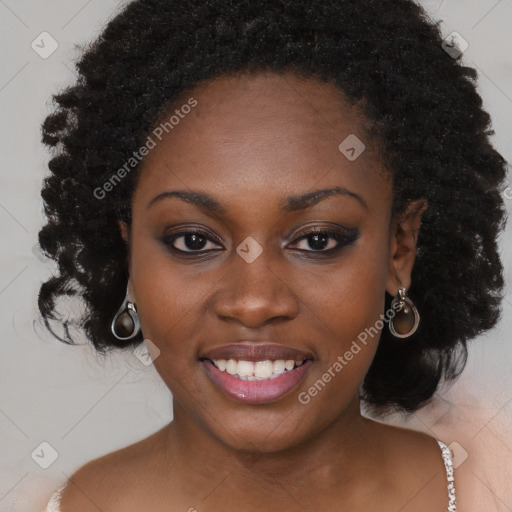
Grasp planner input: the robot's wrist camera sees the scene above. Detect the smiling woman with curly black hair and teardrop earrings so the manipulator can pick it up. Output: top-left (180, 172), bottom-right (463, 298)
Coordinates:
top-left (39, 0), bottom-right (506, 512)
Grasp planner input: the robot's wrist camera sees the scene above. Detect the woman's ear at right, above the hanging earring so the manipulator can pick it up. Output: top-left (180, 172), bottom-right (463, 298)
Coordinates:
top-left (386, 199), bottom-right (428, 297)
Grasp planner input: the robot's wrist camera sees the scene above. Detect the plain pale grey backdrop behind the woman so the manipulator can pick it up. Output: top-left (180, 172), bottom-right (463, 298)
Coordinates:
top-left (0, 0), bottom-right (512, 512)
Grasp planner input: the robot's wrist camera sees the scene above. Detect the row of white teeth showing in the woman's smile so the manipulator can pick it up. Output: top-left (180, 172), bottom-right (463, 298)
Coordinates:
top-left (212, 359), bottom-right (305, 380)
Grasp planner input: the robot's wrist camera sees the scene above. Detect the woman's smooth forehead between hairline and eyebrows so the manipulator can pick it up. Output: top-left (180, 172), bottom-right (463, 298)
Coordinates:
top-left (136, 72), bottom-right (388, 210)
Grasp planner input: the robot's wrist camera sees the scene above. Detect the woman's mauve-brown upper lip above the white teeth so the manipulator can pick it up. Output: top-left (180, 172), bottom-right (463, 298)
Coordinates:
top-left (200, 341), bottom-right (313, 361)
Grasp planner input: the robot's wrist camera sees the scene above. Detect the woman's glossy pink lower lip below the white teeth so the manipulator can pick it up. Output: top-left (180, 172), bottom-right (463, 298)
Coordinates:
top-left (203, 359), bottom-right (312, 404)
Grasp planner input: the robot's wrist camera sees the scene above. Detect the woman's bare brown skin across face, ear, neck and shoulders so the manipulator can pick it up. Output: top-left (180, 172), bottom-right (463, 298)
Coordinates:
top-left (62, 73), bottom-right (456, 512)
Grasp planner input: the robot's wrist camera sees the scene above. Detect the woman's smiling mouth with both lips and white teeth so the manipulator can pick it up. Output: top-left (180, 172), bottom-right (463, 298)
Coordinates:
top-left (199, 342), bottom-right (314, 404)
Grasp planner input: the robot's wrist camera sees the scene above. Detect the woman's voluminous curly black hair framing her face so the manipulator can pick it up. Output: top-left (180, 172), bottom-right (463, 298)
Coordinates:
top-left (38, 0), bottom-right (506, 414)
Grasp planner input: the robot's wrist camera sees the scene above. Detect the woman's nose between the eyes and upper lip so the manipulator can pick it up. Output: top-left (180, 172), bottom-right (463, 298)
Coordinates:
top-left (214, 247), bottom-right (299, 328)
